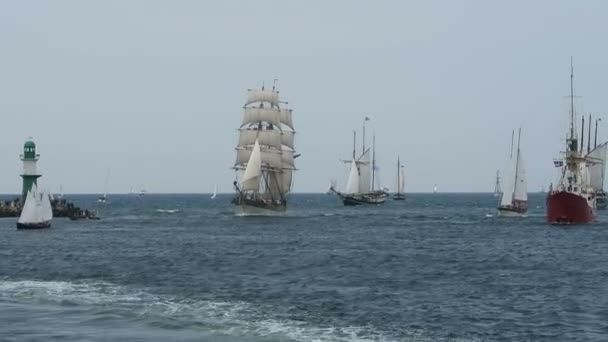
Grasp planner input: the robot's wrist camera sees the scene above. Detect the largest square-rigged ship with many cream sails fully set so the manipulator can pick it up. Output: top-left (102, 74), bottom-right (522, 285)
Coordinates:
top-left (232, 85), bottom-right (299, 215)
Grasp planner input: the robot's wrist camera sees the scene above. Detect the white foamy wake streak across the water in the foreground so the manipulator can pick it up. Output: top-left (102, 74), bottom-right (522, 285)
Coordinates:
top-left (0, 280), bottom-right (410, 342)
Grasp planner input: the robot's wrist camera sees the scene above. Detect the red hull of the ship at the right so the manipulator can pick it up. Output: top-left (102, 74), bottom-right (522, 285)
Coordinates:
top-left (547, 191), bottom-right (595, 224)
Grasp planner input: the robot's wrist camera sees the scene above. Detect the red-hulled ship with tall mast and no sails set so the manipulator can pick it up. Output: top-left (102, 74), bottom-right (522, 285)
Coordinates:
top-left (547, 63), bottom-right (596, 224)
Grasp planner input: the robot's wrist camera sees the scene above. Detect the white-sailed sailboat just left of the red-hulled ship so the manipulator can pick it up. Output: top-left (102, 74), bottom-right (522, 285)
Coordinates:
top-left (497, 128), bottom-right (528, 216)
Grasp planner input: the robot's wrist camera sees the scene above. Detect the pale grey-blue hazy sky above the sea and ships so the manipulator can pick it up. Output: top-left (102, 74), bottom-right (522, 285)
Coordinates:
top-left (0, 0), bottom-right (608, 193)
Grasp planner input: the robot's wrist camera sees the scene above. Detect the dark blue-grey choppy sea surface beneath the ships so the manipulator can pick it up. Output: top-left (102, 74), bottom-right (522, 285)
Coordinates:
top-left (0, 194), bottom-right (608, 341)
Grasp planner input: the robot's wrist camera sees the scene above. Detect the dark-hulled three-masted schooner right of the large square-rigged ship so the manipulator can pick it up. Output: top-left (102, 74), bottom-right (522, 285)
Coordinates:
top-left (331, 124), bottom-right (388, 206)
